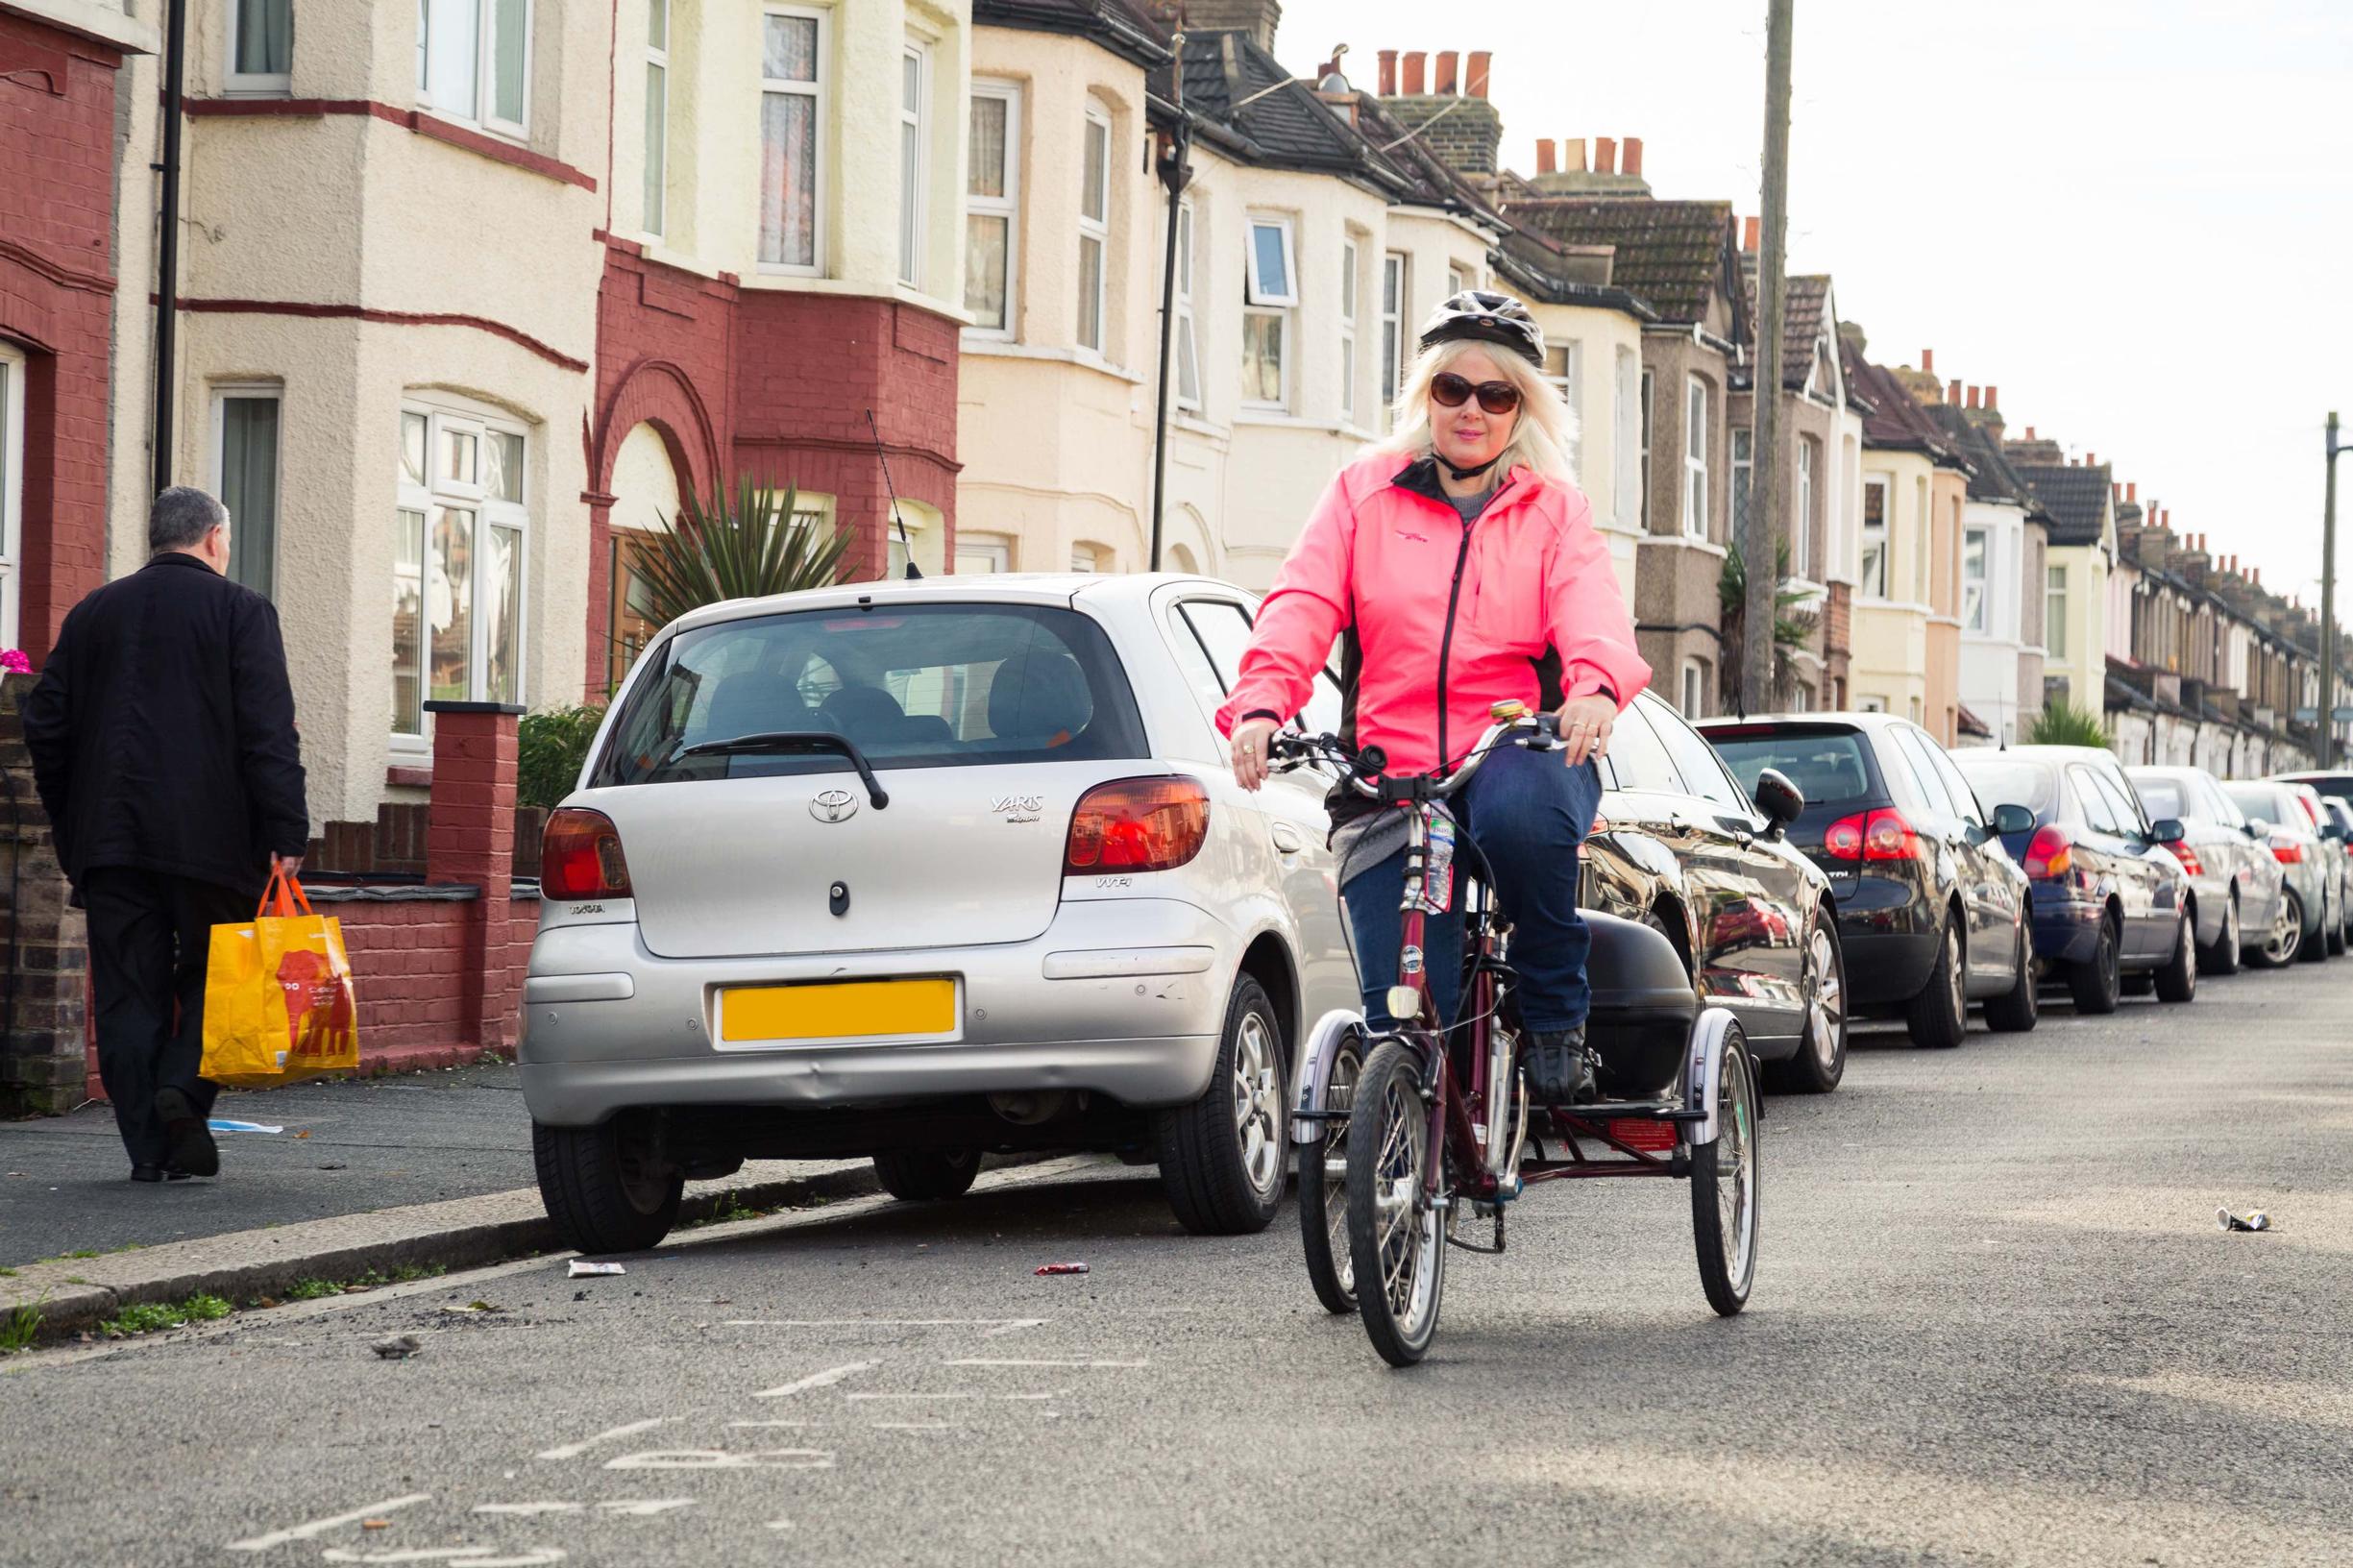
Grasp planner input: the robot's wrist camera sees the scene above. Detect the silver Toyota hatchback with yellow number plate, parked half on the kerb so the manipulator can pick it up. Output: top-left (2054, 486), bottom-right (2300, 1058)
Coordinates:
top-left (520, 575), bottom-right (1358, 1250)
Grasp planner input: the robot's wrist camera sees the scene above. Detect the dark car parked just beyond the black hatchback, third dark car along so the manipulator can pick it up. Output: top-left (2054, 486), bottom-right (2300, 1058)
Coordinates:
top-left (1953, 747), bottom-right (2197, 1013)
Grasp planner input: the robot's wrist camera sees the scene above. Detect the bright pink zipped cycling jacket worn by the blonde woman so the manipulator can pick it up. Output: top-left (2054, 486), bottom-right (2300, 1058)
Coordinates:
top-left (1216, 452), bottom-right (1650, 772)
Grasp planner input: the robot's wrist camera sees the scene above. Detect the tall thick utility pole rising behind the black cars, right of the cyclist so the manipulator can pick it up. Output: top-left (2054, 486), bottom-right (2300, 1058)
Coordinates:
top-left (1739, 0), bottom-right (1796, 713)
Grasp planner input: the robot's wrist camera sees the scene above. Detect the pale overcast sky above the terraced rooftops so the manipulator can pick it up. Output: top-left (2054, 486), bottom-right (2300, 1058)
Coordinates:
top-left (1275, 0), bottom-right (2353, 602)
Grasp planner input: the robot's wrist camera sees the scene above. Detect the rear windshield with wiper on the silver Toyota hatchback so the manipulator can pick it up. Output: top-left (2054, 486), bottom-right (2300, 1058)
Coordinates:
top-left (588, 605), bottom-right (1143, 786)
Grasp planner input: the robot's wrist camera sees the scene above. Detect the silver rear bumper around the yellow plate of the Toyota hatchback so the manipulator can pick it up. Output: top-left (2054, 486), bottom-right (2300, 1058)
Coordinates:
top-left (518, 899), bottom-right (1240, 1125)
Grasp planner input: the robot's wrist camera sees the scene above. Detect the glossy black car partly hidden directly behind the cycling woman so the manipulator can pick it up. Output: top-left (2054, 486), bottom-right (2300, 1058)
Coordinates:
top-left (1579, 692), bottom-right (1847, 1092)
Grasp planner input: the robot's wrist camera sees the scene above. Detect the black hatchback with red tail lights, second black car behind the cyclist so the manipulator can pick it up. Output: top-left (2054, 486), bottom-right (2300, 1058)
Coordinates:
top-left (1699, 713), bottom-right (2035, 1045)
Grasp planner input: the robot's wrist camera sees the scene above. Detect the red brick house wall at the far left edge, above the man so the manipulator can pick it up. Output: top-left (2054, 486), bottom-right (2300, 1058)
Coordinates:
top-left (0, 10), bottom-right (122, 666)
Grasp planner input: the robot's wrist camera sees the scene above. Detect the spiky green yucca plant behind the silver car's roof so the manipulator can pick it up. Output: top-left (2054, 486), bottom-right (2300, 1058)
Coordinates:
top-left (635, 476), bottom-right (856, 626)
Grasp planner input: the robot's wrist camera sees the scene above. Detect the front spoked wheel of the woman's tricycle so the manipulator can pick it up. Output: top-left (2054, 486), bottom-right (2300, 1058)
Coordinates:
top-left (1348, 1041), bottom-right (1447, 1365)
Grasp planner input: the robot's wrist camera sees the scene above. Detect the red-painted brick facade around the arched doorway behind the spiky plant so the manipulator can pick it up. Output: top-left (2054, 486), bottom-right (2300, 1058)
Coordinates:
top-left (586, 237), bottom-right (960, 699)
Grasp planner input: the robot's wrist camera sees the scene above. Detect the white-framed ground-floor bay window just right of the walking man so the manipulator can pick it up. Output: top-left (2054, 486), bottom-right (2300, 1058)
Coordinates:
top-left (391, 404), bottom-right (529, 737)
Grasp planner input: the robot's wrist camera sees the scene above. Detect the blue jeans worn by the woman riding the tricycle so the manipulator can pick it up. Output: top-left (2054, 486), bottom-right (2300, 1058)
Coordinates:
top-left (1341, 747), bottom-right (1603, 1034)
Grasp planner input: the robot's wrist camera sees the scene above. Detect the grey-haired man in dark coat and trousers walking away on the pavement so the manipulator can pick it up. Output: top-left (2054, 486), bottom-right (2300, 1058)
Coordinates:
top-left (23, 485), bottom-right (310, 1182)
